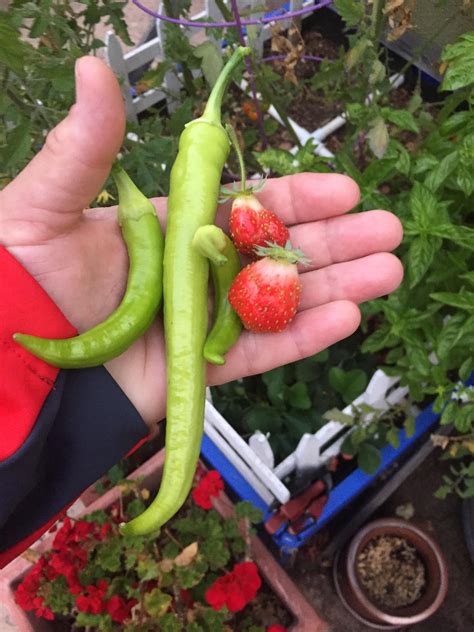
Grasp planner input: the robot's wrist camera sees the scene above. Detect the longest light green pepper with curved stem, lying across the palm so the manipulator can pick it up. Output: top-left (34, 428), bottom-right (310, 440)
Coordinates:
top-left (122, 47), bottom-right (250, 535)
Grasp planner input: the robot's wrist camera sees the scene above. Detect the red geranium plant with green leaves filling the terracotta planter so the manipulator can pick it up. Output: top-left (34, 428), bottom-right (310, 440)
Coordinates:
top-left (15, 471), bottom-right (290, 632)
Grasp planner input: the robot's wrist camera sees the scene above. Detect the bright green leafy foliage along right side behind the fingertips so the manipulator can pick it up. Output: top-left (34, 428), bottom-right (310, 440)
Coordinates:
top-left (258, 17), bottom-right (474, 494)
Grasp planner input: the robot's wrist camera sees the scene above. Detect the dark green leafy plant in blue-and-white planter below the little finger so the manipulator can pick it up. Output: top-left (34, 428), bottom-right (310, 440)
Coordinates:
top-left (212, 335), bottom-right (375, 462)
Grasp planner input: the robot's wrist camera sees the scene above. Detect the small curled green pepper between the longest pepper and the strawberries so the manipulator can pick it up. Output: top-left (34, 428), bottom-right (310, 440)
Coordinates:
top-left (193, 224), bottom-right (242, 364)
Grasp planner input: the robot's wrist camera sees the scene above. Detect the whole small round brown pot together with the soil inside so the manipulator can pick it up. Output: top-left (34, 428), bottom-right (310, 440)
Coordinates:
top-left (333, 518), bottom-right (448, 630)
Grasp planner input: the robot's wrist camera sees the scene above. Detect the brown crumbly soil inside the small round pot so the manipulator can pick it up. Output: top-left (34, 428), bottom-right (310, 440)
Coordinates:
top-left (356, 535), bottom-right (426, 609)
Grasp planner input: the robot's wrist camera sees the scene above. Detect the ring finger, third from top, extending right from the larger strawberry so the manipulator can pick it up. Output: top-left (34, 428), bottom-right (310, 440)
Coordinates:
top-left (299, 252), bottom-right (403, 310)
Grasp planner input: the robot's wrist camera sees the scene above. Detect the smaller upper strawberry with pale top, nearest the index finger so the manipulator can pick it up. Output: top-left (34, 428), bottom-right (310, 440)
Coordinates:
top-left (230, 193), bottom-right (289, 259)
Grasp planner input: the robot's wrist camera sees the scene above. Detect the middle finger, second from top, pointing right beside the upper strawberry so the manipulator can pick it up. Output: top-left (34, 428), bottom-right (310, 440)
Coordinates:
top-left (290, 211), bottom-right (403, 272)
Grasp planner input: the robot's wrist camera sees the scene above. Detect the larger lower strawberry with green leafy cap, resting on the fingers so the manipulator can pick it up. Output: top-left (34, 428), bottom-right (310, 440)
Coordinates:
top-left (229, 242), bottom-right (308, 333)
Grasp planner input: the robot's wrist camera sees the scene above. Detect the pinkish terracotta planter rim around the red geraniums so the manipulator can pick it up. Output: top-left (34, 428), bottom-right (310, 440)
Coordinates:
top-left (0, 450), bottom-right (327, 632)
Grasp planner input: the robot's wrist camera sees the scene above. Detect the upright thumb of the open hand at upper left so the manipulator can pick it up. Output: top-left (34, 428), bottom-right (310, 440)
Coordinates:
top-left (1, 57), bottom-right (125, 236)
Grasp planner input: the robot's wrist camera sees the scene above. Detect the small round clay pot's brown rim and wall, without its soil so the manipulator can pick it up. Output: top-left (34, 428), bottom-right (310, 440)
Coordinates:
top-left (333, 518), bottom-right (448, 630)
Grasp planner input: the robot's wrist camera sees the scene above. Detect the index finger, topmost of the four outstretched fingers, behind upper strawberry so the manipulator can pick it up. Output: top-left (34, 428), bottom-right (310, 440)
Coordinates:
top-left (222, 173), bottom-right (360, 226)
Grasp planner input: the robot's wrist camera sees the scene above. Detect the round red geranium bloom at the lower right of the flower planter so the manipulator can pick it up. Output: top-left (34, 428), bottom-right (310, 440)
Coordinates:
top-left (204, 562), bottom-right (262, 612)
